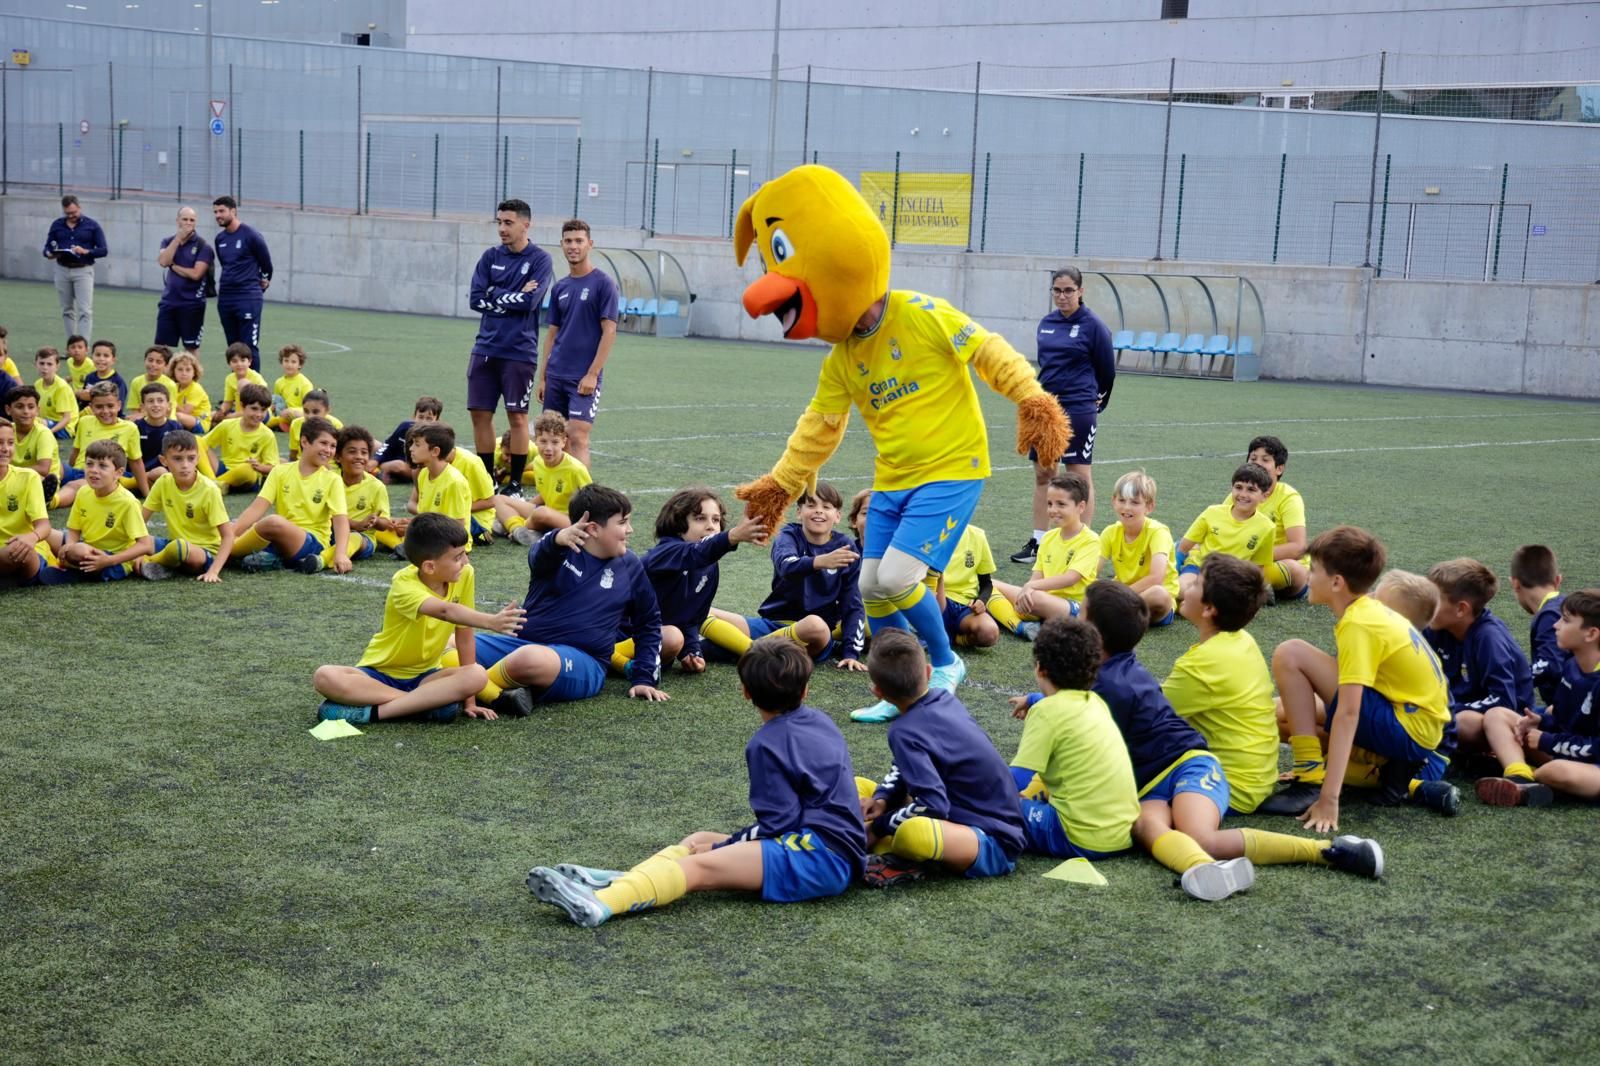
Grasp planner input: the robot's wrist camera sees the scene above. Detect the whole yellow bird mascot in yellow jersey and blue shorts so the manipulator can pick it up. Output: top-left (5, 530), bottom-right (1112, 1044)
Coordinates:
top-left (733, 166), bottom-right (1072, 722)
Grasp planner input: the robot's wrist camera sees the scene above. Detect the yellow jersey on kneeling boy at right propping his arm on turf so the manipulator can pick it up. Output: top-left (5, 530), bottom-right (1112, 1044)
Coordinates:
top-left (1333, 595), bottom-right (1450, 751)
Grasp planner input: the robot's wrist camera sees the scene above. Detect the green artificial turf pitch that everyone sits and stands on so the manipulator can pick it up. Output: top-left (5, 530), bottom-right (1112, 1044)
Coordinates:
top-left (0, 282), bottom-right (1600, 1063)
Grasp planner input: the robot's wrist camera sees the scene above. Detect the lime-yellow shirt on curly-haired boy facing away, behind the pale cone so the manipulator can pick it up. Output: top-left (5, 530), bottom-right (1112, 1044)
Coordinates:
top-left (1011, 690), bottom-right (1139, 852)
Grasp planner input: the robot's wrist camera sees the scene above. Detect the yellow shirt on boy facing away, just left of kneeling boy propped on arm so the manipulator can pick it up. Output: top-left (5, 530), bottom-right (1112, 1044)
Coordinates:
top-left (1162, 629), bottom-right (1278, 815)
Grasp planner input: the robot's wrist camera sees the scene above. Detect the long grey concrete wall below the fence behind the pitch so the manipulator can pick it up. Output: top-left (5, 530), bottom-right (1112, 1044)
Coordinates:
top-left (0, 195), bottom-right (1600, 399)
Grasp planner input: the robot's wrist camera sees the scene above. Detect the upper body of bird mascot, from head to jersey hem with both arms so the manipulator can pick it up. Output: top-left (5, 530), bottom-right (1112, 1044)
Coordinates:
top-left (733, 165), bottom-right (1072, 530)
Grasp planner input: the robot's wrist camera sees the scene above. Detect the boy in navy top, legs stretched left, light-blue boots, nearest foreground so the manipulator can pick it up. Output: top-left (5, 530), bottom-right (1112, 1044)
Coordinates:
top-left (528, 640), bottom-right (867, 927)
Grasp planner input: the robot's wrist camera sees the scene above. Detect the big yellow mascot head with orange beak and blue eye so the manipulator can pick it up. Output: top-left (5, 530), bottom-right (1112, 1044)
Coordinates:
top-left (733, 165), bottom-right (890, 344)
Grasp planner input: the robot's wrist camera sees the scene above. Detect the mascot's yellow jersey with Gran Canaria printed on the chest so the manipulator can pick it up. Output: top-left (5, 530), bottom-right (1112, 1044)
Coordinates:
top-left (811, 290), bottom-right (990, 491)
